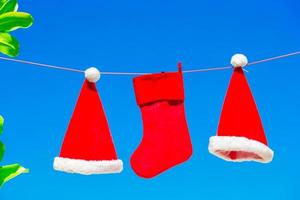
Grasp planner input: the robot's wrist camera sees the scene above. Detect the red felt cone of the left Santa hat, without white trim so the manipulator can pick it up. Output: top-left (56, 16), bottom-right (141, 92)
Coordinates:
top-left (60, 81), bottom-right (117, 161)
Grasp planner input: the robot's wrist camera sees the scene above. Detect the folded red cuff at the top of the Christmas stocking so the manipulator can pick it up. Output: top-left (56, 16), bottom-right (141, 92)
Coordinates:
top-left (133, 71), bottom-right (184, 106)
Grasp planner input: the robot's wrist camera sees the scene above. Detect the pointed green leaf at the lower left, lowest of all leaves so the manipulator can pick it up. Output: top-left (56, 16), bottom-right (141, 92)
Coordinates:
top-left (0, 164), bottom-right (29, 187)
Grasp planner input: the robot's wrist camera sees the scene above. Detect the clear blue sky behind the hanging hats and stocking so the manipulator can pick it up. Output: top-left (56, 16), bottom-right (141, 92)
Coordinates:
top-left (0, 0), bottom-right (300, 200)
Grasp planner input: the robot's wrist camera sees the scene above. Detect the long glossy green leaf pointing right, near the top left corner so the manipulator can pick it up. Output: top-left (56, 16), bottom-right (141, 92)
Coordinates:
top-left (0, 12), bottom-right (33, 32)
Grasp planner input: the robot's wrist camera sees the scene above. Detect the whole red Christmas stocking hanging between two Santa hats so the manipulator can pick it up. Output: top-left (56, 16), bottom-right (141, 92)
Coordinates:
top-left (131, 67), bottom-right (192, 178)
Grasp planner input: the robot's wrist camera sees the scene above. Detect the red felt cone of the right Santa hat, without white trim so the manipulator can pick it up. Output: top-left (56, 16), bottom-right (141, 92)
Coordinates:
top-left (218, 68), bottom-right (267, 145)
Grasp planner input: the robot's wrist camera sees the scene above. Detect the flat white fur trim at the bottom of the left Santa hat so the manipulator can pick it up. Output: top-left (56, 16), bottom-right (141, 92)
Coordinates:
top-left (53, 157), bottom-right (123, 175)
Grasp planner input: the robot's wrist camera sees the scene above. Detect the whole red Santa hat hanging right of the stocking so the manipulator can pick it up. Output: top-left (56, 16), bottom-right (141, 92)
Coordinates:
top-left (209, 54), bottom-right (273, 163)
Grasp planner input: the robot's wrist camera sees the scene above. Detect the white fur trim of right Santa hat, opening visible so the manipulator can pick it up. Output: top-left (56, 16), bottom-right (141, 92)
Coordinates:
top-left (208, 136), bottom-right (274, 163)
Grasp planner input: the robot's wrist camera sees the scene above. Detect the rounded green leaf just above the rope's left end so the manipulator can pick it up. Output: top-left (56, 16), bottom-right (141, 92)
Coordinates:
top-left (0, 33), bottom-right (20, 56)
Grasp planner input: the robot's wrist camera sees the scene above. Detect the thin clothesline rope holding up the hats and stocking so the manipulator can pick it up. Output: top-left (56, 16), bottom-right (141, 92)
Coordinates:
top-left (0, 51), bottom-right (300, 75)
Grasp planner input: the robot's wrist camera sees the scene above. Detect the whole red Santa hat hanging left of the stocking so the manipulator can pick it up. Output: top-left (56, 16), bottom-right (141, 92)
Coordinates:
top-left (53, 68), bottom-right (123, 175)
